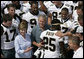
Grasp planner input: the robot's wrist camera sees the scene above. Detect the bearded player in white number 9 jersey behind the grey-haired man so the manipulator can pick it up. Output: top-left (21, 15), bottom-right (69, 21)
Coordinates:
top-left (22, 2), bottom-right (45, 35)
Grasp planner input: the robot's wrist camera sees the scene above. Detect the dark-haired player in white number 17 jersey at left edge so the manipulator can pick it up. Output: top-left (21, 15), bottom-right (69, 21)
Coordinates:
top-left (1, 14), bottom-right (16, 58)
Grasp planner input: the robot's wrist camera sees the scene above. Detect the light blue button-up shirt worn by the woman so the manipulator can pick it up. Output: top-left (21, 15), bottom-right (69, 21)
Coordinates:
top-left (14, 34), bottom-right (32, 58)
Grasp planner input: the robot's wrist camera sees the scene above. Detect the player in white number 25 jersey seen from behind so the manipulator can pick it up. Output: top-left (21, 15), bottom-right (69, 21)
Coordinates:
top-left (34, 20), bottom-right (65, 58)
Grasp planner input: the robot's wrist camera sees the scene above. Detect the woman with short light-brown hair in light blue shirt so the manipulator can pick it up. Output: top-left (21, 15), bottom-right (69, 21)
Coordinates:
top-left (15, 20), bottom-right (32, 58)
